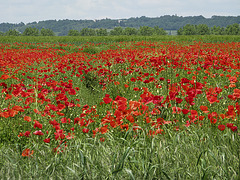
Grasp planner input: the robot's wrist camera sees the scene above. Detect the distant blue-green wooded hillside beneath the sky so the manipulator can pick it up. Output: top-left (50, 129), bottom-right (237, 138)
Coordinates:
top-left (0, 15), bottom-right (240, 36)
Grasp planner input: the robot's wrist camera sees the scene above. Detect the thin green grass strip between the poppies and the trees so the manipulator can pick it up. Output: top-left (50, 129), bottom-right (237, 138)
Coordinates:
top-left (0, 35), bottom-right (240, 45)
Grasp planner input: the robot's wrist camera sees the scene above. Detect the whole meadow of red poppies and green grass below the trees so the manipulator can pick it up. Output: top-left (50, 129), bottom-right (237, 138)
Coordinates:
top-left (0, 36), bottom-right (240, 179)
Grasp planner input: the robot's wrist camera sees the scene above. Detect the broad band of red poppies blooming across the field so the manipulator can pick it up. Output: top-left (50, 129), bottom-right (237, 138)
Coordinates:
top-left (0, 41), bottom-right (240, 156)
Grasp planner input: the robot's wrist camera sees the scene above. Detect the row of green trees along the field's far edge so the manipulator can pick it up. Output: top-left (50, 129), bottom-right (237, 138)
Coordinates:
top-left (0, 23), bottom-right (240, 36)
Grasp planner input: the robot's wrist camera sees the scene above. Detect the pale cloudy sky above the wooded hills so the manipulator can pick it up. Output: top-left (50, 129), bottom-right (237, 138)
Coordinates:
top-left (0, 0), bottom-right (240, 23)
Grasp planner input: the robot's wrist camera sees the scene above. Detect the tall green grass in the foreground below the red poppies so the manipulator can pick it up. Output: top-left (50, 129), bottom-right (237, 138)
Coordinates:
top-left (0, 127), bottom-right (240, 179)
